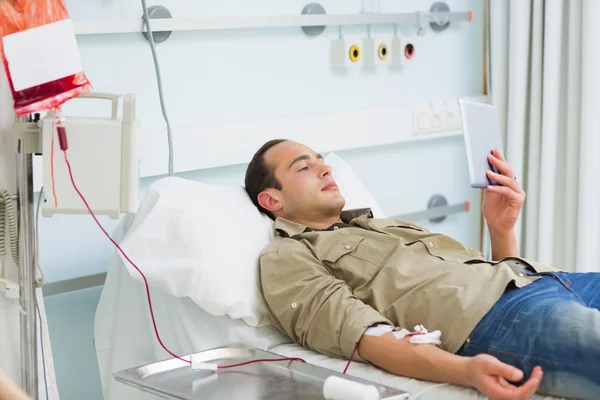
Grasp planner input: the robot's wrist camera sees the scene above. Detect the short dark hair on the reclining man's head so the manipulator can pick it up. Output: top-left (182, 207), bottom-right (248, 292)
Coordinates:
top-left (245, 139), bottom-right (287, 219)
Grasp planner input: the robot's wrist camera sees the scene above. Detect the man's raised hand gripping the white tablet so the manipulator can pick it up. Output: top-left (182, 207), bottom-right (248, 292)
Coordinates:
top-left (483, 149), bottom-right (525, 236)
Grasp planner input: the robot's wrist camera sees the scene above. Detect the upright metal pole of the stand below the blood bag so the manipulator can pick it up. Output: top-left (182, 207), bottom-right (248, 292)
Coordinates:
top-left (17, 139), bottom-right (38, 399)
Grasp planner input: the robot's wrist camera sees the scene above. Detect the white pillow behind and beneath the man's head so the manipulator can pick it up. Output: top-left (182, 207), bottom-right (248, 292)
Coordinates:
top-left (121, 153), bottom-right (383, 326)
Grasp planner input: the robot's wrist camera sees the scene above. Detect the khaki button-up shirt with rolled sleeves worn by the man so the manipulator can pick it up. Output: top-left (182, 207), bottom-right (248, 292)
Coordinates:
top-left (260, 209), bottom-right (555, 358)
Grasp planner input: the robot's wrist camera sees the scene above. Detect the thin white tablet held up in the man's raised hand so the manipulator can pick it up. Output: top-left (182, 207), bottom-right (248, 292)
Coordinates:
top-left (458, 99), bottom-right (502, 189)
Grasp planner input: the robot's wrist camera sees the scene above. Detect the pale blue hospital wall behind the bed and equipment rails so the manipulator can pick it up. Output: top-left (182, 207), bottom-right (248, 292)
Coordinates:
top-left (40, 0), bottom-right (483, 400)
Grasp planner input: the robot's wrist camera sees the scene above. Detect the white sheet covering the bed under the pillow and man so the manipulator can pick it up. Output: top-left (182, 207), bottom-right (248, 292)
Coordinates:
top-left (94, 215), bottom-right (555, 400)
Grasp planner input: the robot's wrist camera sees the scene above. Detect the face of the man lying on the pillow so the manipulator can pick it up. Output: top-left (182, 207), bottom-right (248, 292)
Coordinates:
top-left (265, 141), bottom-right (345, 220)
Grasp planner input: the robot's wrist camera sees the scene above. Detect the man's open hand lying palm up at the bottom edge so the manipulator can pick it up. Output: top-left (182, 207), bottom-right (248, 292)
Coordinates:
top-left (469, 354), bottom-right (543, 400)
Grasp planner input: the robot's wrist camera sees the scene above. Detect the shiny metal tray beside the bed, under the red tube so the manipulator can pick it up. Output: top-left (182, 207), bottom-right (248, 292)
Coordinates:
top-left (114, 344), bottom-right (408, 400)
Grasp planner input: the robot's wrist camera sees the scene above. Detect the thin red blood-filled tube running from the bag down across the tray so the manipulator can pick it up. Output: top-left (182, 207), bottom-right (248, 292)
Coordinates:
top-left (57, 128), bottom-right (306, 369)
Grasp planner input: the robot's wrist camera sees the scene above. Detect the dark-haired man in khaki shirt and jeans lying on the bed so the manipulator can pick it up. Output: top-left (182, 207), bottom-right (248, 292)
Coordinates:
top-left (245, 141), bottom-right (600, 399)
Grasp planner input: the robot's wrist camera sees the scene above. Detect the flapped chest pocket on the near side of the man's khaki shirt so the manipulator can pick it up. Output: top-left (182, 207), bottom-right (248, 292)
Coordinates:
top-left (322, 235), bottom-right (398, 289)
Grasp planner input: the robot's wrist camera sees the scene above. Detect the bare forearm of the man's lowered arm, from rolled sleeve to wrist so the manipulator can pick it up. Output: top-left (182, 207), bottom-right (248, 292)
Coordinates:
top-left (358, 333), bottom-right (471, 386)
